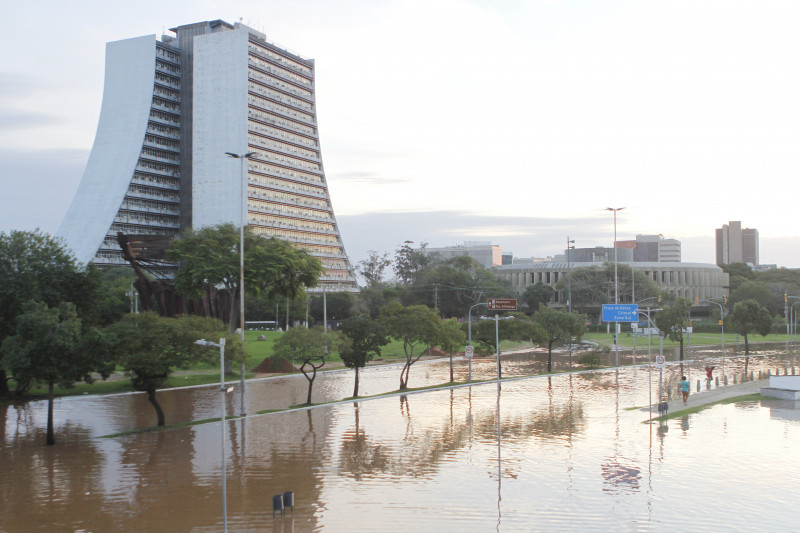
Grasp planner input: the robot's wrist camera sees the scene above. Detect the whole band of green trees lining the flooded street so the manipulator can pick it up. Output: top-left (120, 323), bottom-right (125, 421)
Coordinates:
top-left (0, 225), bottom-right (800, 443)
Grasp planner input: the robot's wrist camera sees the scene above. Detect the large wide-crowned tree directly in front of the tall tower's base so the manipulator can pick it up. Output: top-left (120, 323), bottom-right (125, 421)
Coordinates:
top-left (167, 224), bottom-right (323, 332)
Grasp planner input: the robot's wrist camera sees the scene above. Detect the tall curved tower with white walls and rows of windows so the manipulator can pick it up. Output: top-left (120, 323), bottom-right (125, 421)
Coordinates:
top-left (58, 20), bottom-right (357, 291)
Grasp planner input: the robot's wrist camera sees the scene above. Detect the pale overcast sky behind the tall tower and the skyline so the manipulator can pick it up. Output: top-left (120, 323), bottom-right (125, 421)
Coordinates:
top-left (0, 0), bottom-right (800, 267)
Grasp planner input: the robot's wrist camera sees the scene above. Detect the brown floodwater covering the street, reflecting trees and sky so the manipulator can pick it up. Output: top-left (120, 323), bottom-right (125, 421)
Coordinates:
top-left (0, 344), bottom-right (800, 533)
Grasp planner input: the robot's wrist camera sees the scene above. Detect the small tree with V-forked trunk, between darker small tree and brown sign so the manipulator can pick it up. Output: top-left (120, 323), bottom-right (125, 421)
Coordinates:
top-left (381, 302), bottom-right (440, 390)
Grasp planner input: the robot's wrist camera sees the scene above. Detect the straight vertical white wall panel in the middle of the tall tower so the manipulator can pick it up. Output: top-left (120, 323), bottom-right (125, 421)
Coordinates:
top-left (192, 30), bottom-right (248, 228)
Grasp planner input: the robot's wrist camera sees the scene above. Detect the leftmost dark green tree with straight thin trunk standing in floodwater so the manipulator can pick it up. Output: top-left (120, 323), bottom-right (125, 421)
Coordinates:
top-left (2, 300), bottom-right (113, 445)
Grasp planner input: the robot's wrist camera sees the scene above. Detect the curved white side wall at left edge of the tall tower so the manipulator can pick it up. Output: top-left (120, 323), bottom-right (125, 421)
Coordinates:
top-left (56, 35), bottom-right (156, 263)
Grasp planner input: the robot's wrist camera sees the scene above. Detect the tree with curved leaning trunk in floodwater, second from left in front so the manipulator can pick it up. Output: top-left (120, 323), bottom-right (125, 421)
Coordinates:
top-left (106, 312), bottom-right (239, 426)
